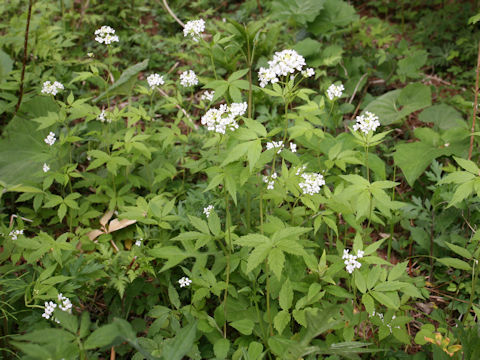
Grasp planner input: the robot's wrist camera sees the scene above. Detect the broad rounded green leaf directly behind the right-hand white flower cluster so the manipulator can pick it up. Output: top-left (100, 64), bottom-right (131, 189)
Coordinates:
top-left (365, 84), bottom-right (432, 125)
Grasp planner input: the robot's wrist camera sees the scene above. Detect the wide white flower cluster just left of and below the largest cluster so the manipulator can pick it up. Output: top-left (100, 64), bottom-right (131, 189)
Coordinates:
top-left (201, 103), bottom-right (248, 134)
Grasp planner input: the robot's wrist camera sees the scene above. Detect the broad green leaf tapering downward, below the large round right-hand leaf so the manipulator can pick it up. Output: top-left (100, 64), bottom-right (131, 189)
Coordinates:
top-left (393, 142), bottom-right (450, 186)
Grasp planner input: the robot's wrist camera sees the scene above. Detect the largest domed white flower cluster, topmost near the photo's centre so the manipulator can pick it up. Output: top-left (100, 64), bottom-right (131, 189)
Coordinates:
top-left (258, 50), bottom-right (313, 87)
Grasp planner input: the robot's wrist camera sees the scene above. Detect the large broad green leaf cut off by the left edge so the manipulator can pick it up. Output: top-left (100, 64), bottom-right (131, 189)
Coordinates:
top-left (0, 96), bottom-right (58, 185)
